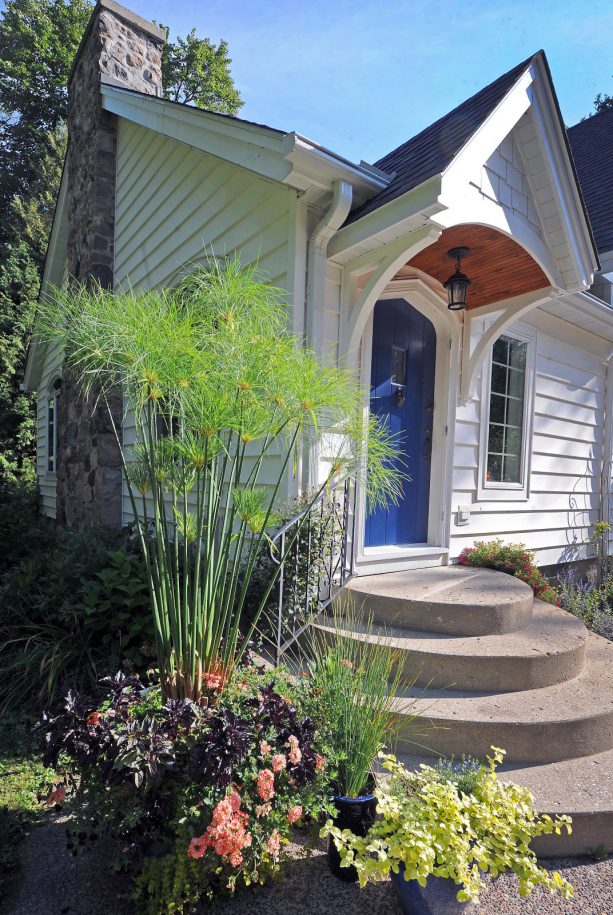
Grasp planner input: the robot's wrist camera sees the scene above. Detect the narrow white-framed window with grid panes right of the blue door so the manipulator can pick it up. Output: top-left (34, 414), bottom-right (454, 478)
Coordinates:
top-left (479, 334), bottom-right (534, 499)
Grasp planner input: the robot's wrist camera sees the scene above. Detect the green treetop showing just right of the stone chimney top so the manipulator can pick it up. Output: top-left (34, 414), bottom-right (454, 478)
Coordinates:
top-left (162, 29), bottom-right (244, 114)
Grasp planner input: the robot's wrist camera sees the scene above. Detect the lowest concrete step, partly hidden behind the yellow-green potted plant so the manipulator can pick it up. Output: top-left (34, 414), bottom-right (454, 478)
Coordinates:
top-left (398, 750), bottom-right (613, 858)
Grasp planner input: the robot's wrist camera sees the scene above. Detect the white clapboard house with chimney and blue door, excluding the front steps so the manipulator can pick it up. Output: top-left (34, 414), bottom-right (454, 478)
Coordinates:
top-left (25, 0), bottom-right (613, 573)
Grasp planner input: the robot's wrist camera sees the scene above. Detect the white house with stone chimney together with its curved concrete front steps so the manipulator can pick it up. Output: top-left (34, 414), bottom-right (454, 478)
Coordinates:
top-left (25, 0), bottom-right (613, 853)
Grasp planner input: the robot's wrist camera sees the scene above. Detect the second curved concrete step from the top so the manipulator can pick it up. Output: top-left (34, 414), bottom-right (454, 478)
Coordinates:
top-left (315, 601), bottom-right (588, 692)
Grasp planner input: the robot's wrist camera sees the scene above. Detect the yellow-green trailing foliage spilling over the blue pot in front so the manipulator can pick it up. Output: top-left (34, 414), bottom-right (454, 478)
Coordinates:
top-left (321, 747), bottom-right (573, 902)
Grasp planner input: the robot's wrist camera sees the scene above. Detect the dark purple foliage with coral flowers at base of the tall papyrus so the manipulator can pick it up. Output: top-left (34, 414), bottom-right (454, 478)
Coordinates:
top-left (40, 667), bottom-right (327, 915)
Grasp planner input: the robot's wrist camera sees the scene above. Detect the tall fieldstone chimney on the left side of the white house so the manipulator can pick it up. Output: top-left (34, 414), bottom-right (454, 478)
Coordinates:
top-left (57, 0), bottom-right (166, 530)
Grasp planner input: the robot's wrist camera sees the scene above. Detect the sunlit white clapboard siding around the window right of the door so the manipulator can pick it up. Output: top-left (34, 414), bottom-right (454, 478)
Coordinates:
top-left (451, 312), bottom-right (606, 565)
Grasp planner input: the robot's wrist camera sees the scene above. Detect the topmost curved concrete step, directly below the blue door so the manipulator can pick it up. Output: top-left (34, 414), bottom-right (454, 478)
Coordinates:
top-left (337, 566), bottom-right (533, 636)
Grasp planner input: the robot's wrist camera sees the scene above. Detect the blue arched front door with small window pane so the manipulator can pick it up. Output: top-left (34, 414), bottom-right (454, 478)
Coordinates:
top-left (365, 299), bottom-right (436, 547)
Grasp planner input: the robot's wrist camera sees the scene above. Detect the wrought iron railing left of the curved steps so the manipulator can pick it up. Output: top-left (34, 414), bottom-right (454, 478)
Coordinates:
top-left (270, 480), bottom-right (356, 664)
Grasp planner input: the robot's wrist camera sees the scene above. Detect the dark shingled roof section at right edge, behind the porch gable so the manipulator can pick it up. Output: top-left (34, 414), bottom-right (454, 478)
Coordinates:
top-left (568, 108), bottom-right (613, 252)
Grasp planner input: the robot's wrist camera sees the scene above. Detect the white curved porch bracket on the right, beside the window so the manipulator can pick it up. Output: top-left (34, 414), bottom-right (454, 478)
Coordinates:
top-left (458, 286), bottom-right (564, 404)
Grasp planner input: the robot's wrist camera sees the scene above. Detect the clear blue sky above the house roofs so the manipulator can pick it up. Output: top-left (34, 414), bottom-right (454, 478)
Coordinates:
top-left (123, 0), bottom-right (613, 162)
